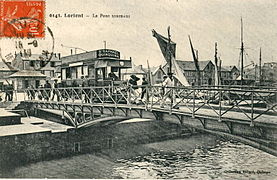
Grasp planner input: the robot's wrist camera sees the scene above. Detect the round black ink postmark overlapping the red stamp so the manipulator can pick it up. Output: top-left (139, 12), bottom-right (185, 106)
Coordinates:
top-left (0, 17), bottom-right (55, 70)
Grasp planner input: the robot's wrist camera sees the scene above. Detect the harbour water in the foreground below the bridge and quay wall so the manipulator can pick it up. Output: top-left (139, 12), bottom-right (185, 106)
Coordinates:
top-left (0, 137), bottom-right (277, 180)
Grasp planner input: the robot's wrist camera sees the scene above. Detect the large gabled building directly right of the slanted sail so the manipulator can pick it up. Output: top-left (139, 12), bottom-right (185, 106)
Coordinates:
top-left (174, 60), bottom-right (215, 86)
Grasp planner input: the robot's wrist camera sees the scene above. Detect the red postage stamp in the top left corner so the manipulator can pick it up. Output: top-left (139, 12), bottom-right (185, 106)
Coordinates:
top-left (0, 0), bottom-right (45, 38)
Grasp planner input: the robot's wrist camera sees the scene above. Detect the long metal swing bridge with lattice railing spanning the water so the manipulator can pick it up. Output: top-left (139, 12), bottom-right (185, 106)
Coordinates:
top-left (5, 85), bottom-right (277, 154)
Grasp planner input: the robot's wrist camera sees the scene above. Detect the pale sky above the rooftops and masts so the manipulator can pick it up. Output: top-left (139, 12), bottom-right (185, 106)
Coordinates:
top-left (46, 0), bottom-right (277, 66)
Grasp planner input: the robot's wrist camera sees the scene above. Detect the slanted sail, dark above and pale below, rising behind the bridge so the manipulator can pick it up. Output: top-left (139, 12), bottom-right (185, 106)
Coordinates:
top-left (152, 30), bottom-right (190, 86)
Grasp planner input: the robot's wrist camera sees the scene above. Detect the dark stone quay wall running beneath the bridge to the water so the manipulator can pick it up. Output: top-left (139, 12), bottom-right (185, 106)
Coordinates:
top-left (0, 120), bottom-right (189, 167)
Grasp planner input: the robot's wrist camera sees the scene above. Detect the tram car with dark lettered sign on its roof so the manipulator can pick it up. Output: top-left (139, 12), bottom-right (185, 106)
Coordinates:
top-left (61, 49), bottom-right (132, 86)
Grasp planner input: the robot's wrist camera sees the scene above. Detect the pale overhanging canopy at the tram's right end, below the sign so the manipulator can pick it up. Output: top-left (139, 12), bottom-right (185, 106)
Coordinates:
top-left (95, 59), bottom-right (132, 68)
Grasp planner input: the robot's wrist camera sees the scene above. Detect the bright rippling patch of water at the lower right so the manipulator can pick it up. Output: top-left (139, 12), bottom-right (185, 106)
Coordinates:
top-left (114, 142), bottom-right (277, 180)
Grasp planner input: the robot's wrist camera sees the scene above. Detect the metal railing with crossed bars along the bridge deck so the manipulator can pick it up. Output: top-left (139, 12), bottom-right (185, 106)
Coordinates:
top-left (25, 86), bottom-right (277, 125)
